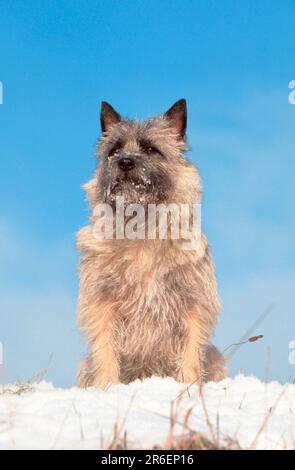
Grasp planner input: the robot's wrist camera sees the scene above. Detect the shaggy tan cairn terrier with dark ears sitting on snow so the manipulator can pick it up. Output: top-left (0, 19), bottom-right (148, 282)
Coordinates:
top-left (78, 99), bottom-right (226, 388)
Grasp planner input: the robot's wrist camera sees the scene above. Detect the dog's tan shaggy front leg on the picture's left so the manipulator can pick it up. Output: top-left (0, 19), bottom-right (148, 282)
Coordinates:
top-left (79, 302), bottom-right (119, 389)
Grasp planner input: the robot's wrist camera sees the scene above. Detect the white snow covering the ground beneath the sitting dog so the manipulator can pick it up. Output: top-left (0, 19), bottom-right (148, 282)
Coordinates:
top-left (0, 375), bottom-right (295, 449)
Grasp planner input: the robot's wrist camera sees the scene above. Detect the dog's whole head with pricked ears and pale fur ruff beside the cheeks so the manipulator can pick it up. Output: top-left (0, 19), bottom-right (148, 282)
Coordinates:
top-left (86, 99), bottom-right (201, 205)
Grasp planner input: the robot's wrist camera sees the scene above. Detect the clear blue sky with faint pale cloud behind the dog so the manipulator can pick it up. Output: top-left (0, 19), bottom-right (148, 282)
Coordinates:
top-left (0, 0), bottom-right (295, 386)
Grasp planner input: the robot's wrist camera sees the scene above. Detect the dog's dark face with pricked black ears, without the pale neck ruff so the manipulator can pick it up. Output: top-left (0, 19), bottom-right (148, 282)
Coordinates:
top-left (98, 100), bottom-right (186, 204)
